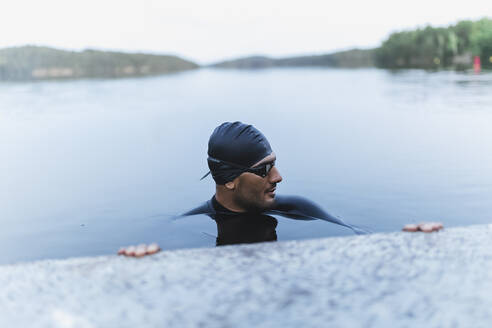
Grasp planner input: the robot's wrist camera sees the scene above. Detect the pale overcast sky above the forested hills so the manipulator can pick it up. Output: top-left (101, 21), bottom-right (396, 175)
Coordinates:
top-left (0, 0), bottom-right (492, 63)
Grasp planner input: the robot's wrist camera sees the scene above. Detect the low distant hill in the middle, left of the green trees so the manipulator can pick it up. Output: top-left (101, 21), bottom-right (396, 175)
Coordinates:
top-left (211, 49), bottom-right (375, 69)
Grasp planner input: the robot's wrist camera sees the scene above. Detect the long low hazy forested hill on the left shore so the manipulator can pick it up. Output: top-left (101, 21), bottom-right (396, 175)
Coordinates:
top-left (0, 46), bottom-right (198, 80)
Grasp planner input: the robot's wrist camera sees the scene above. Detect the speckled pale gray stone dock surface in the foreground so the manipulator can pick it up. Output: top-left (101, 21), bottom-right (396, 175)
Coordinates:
top-left (0, 225), bottom-right (492, 328)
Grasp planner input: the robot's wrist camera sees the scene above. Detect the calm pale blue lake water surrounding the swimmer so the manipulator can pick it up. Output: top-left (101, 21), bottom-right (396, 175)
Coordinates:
top-left (0, 69), bottom-right (492, 263)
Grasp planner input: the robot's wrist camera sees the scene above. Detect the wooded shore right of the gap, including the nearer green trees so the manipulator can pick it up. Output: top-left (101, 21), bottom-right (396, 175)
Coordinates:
top-left (211, 18), bottom-right (492, 69)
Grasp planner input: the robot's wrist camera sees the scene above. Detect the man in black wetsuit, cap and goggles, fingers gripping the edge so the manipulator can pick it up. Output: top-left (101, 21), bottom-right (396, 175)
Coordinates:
top-left (119, 122), bottom-right (442, 256)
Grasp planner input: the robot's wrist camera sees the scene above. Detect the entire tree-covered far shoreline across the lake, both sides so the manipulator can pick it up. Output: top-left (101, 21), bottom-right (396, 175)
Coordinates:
top-left (0, 18), bottom-right (492, 81)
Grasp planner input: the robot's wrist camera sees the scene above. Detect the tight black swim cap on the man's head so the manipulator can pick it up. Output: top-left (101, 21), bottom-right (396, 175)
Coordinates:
top-left (207, 122), bottom-right (272, 184)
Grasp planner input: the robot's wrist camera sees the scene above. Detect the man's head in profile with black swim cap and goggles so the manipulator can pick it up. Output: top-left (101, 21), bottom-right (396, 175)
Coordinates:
top-left (208, 122), bottom-right (282, 212)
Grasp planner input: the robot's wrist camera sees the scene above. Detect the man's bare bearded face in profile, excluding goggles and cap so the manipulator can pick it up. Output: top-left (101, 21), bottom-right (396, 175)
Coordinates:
top-left (234, 153), bottom-right (282, 211)
